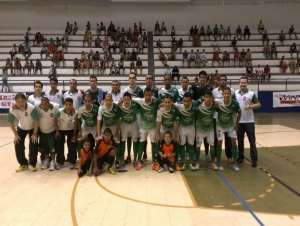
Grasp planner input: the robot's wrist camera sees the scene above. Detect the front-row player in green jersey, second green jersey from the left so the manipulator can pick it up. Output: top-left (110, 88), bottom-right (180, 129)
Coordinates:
top-left (97, 93), bottom-right (124, 169)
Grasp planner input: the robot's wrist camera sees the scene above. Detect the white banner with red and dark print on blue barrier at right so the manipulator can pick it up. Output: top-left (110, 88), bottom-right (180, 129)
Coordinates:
top-left (273, 91), bottom-right (300, 108)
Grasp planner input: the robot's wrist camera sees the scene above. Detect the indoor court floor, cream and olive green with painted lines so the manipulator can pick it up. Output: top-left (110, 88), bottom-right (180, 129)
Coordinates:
top-left (0, 114), bottom-right (300, 226)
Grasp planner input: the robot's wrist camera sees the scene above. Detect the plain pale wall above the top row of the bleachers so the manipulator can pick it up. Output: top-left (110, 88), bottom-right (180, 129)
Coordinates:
top-left (0, 1), bottom-right (300, 32)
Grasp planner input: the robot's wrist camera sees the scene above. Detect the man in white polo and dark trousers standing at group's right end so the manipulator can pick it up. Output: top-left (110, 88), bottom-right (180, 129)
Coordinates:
top-left (235, 77), bottom-right (261, 167)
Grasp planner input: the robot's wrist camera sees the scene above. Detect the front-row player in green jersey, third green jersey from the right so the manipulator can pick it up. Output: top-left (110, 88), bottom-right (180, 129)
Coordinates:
top-left (175, 92), bottom-right (201, 170)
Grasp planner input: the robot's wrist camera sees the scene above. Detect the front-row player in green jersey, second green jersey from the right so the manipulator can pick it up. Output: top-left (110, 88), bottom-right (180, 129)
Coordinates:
top-left (195, 89), bottom-right (218, 170)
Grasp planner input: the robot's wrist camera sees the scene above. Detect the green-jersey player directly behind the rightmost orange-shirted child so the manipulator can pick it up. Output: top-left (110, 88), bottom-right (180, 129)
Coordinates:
top-left (156, 94), bottom-right (180, 171)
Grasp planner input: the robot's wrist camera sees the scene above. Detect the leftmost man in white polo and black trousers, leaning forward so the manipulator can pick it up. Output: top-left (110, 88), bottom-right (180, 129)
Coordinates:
top-left (7, 93), bottom-right (39, 172)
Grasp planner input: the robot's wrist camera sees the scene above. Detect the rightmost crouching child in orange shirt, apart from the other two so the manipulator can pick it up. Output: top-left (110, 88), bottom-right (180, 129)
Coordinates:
top-left (157, 131), bottom-right (175, 173)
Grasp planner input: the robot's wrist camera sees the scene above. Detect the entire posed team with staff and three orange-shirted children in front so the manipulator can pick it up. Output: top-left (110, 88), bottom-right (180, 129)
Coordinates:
top-left (7, 71), bottom-right (260, 177)
